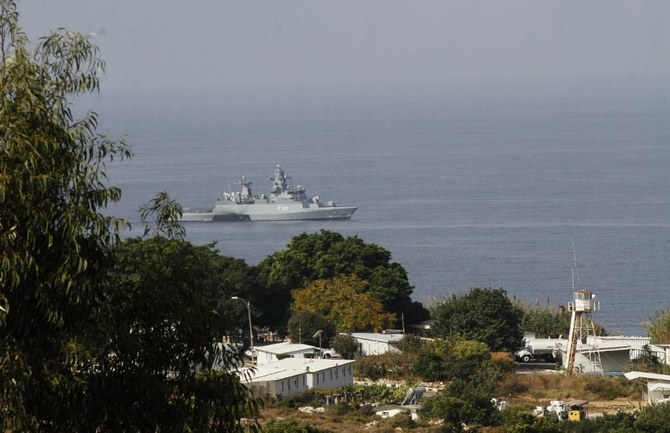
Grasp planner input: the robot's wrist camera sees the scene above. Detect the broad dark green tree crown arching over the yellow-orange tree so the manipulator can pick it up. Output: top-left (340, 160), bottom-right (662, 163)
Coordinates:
top-left (255, 230), bottom-right (427, 326)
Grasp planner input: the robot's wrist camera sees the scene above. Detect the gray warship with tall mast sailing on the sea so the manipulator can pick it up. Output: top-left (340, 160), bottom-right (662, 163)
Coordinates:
top-left (182, 164), bottom-right (358, 221)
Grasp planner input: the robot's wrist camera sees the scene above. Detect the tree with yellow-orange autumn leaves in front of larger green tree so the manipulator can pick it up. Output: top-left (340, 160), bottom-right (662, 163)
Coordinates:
top-left (292, 275), bottom-right (394, 332)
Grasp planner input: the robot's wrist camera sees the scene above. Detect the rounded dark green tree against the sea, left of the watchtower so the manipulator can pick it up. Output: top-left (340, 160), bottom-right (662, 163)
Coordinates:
top-left (431, 288), bottom-right (523, 352)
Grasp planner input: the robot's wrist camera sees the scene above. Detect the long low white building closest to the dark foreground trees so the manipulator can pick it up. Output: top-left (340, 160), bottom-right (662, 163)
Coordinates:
top-left (242, 358), bottom-right (354, 397)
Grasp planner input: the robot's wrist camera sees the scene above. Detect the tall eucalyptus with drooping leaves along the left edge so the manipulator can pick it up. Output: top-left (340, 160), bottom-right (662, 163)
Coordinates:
top-left (0, 0), bottom-right (131, 431)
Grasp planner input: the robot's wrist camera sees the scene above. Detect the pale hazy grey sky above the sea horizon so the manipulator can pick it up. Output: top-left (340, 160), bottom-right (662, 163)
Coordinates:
top-left (17, 0), bottom-right (670, 88)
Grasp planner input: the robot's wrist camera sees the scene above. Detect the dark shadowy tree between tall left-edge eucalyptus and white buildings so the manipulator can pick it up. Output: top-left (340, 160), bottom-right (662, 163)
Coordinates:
top-left (90, 237), bottom-right (257, 431)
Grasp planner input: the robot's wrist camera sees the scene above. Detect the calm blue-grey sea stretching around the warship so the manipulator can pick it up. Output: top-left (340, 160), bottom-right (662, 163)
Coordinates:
top-left (96, 76), bottom-right (670, 335)
